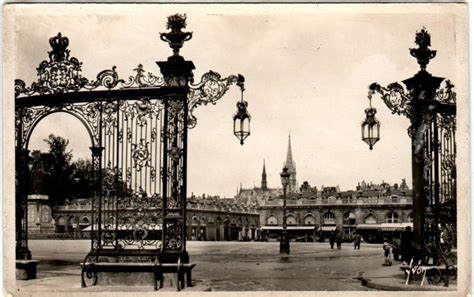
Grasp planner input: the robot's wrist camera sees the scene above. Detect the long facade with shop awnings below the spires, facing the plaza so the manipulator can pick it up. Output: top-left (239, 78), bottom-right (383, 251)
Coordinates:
top-left (258, 185), bottom-right (413, 242)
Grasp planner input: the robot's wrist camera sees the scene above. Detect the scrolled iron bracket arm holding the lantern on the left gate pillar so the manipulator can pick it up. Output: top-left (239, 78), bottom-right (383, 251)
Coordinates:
top-left (188, 70), bottom-right (245, 129)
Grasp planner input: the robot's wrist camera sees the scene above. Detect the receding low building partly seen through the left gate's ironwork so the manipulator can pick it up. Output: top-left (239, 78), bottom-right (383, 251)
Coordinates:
top-left (47, 197), bottom-right (260, 240)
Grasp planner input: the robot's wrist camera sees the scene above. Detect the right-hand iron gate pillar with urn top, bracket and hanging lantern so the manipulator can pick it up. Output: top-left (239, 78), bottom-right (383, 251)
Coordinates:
top-left (363, 28), bottom-right (456, 286)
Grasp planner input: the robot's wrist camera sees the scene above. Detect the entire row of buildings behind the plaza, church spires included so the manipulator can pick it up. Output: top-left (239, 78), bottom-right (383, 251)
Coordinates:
top-left (28, 136), bottom-right (413, 242)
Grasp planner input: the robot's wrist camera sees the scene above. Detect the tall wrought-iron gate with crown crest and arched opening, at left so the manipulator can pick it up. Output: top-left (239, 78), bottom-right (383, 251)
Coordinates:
top-left (15, 14), bottom-right (248, 262)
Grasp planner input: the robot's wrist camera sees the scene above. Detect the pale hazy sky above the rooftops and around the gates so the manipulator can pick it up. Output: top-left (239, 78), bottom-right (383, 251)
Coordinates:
top-left (13, 4), bottom-right (467, 197)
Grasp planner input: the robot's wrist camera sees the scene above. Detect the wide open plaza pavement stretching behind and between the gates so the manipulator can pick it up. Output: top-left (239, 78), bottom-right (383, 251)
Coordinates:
top-left (9, 240), bottom-right (456, 295)
